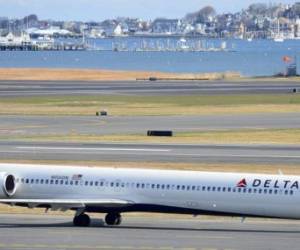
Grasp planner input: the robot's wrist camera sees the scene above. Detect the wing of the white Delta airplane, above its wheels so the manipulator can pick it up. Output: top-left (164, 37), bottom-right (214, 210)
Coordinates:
top-left (0, 199), bottom-right (134, 210)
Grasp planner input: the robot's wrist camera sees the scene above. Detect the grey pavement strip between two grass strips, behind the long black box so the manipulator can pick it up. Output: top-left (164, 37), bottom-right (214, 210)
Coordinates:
top-left (0, 113), bottom-right (300, 136)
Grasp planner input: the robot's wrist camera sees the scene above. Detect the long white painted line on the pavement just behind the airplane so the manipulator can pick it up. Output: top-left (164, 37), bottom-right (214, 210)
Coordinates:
top-left (16, 146), bottom-right (171, 152)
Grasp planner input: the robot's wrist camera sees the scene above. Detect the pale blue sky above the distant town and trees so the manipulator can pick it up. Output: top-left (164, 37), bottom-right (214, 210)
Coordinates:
top-left (0, 0), bottom-right (297, 21)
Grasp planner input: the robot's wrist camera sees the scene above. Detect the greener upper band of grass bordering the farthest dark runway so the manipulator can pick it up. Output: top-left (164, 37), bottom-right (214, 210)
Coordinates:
top-left (0, 94), bottom-right (300, 107)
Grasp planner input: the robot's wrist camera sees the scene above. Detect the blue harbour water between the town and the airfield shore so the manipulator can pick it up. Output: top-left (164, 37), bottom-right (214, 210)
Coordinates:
top-left (0, 38), bottom-right (300, 76)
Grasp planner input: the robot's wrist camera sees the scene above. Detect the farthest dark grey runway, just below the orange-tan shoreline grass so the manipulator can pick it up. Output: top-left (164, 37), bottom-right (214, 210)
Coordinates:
top-left (0, 80), bottom-right (300, 97)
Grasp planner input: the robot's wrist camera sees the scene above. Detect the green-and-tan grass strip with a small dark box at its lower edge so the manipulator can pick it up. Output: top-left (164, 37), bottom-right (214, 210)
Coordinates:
top-left (0, 94), bottom-right (300, 116)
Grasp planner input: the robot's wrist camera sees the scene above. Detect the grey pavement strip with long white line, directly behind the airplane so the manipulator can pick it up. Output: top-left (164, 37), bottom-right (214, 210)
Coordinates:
top-left (0, 141), bottom-right (300, 165)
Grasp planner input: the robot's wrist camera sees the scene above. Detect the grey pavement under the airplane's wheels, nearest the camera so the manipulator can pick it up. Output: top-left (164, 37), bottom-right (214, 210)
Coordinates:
top-left (0, 215), bottom-right (300, 250)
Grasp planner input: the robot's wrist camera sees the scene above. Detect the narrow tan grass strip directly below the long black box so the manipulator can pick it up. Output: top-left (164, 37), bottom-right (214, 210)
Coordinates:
top-left (0, 129), bottom-right (300, 145)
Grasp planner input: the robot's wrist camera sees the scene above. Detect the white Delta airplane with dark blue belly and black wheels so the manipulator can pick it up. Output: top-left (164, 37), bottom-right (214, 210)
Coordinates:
top-left (0, 164), bottom-right (300, 226)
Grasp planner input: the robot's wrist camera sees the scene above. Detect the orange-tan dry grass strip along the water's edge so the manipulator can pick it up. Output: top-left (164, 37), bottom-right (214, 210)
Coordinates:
top-left (0, 68), bottom-right (240, 81)
